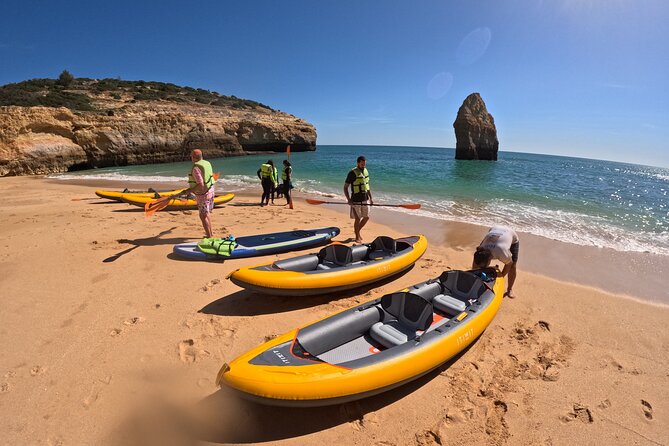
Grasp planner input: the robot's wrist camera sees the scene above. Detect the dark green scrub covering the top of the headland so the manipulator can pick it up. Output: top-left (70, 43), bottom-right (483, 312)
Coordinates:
top-left (0, 70), bottom-right (272, 113)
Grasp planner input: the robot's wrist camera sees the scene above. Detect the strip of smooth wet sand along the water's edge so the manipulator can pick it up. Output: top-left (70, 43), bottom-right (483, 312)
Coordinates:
top-left (44, 178), bottom-right (669, 306)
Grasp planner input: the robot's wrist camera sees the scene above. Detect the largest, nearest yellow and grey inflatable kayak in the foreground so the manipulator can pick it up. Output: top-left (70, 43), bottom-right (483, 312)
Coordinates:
top-left (216, 268), bottom-right (504, 406)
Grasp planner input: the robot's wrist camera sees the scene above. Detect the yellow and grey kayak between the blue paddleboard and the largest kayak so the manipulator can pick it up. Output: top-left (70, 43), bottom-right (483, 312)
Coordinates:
top-left (228, 235), bottom-right (427, 296)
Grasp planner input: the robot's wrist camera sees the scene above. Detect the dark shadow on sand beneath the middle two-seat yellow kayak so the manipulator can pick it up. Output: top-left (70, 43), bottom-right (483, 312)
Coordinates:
top-left (199, 266), bottom-right (413, 316)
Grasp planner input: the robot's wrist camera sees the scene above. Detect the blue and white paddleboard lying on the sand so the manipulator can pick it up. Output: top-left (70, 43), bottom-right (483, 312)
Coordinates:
top-left (172, 227), bottom-right (339, 260)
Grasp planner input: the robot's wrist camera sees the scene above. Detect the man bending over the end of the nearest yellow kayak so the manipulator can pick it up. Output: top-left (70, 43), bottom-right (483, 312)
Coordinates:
top-left (472, 225), bottom-right (519, 299)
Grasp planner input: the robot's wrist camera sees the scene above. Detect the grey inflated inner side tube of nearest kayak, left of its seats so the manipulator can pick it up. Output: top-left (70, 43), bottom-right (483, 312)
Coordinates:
top-left (297, 305), bottom-right (383, 356)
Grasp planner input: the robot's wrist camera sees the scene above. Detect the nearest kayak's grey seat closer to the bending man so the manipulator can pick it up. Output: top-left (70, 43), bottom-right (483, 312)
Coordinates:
top-left (432, 271), bottom-right (486, 316)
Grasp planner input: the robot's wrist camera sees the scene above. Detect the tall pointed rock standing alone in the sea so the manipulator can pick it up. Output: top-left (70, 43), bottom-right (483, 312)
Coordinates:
top-left (453, 93), bottom-right (499, 161)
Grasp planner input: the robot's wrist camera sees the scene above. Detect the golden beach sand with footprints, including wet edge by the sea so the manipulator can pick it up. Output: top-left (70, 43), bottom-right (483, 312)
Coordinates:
top-left (0, 178), bottom-right (669, 445)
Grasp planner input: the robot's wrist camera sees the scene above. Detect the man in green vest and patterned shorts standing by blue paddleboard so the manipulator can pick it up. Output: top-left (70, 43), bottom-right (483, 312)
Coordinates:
top-left (179, 149), bottom-right (215, 238)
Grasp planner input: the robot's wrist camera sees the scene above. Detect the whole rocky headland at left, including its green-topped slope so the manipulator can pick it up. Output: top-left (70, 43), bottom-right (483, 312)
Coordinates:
top-left (0, 78), bottom-right (316, 176)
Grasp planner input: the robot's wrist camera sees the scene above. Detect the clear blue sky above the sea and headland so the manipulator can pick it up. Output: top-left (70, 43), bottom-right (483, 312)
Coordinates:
top-left (0, 0), bottom-right (669, 167)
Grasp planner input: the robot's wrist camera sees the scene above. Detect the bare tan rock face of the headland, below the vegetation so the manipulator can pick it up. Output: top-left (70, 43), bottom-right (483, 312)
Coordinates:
top-left (0, 93), bottom-right (316, 176)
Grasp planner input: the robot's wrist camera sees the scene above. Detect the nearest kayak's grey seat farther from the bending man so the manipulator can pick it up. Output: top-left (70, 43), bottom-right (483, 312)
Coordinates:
top-left (369, 292), bottom-right (433, 348)
